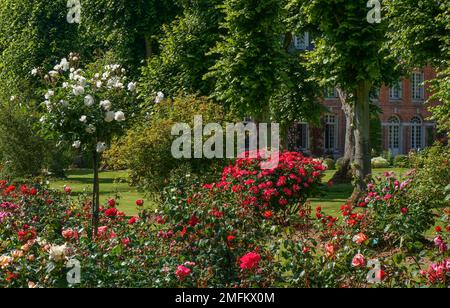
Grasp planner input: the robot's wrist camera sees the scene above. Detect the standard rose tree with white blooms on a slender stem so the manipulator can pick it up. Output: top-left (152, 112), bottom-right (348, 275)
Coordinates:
top-left (36, 53), bottom-right (137, 237)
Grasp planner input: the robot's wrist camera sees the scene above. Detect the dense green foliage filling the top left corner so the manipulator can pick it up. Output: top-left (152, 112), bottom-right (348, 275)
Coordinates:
top-left (0, 0), bottom-right (79, 98)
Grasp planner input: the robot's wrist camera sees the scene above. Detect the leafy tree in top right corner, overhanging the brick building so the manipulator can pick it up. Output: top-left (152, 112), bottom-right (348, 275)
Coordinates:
top-left (385, 0), bottom-right (450, 134)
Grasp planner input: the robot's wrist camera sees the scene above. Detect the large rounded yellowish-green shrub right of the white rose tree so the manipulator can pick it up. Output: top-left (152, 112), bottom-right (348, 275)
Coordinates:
top-left (105, 96), bottom-right (234, 199)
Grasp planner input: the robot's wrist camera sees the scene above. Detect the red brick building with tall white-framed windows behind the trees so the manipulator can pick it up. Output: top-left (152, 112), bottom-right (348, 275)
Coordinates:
top-left (288, 36), bottom-right (436, 157)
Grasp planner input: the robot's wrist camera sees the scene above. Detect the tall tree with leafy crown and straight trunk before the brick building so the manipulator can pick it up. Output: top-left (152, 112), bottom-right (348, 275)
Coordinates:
top-left (293, 0), bottom-right (398, 191)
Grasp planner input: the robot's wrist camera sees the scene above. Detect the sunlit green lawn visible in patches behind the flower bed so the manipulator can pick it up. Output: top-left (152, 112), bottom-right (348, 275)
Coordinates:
top-left (50, 169), bottom-right (407, 216)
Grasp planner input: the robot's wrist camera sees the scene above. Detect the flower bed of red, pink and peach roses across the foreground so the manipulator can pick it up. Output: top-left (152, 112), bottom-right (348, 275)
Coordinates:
top-left (0, 152), bottom-right (450, 287)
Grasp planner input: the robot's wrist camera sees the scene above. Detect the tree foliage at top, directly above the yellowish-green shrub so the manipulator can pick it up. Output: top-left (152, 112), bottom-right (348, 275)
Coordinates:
top-left (141, 0), bottom-right (223, 97)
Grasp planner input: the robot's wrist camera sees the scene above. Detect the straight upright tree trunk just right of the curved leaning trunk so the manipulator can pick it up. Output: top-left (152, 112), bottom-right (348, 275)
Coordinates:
top-left (354, 81), bottom-right (372, 194)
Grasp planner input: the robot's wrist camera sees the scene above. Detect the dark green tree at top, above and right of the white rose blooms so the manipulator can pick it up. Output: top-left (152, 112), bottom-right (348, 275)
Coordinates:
top-left (80, 0), bottom-right (179, 75)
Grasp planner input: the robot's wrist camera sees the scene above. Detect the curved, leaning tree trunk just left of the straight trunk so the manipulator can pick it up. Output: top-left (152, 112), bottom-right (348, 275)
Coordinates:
top-left (332, 89), bottom-right (355, 184)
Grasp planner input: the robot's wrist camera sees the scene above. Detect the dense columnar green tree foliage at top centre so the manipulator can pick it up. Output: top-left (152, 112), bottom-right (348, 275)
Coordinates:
top-left (207, 0), bottom-right (285, 119)
